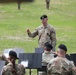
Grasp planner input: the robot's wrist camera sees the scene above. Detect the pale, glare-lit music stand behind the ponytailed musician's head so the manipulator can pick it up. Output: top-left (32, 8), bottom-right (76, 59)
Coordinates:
top-left (4, 48), bottom-right (24, 58)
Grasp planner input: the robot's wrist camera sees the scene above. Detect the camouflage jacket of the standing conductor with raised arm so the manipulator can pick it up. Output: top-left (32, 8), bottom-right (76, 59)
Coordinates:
top-left (28, 25), bottom-right (56, 51)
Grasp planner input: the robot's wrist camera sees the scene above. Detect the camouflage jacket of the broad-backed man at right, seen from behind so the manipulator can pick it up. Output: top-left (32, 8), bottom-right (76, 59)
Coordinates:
top-left (47, 57), bottom-right (76, 75)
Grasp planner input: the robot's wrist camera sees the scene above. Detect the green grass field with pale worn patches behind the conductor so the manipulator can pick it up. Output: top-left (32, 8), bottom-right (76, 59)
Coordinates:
top-left (0, 0), bottom-right (76, 53)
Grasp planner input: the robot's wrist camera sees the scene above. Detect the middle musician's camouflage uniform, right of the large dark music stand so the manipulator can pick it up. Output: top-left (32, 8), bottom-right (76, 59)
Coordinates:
top-left (38, 51), bottom-right (54, 75)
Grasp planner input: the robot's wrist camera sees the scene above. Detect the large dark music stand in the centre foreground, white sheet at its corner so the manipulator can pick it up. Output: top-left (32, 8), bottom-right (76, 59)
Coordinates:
top-left (19, 53), bottom-right (42, 75)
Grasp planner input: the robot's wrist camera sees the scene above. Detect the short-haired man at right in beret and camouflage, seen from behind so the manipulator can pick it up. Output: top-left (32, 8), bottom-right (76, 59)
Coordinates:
top-left (47, 44), bottom-right (76, 75)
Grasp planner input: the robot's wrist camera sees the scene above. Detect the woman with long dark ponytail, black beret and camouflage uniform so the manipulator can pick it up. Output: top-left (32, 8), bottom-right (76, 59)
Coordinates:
top-left (1, 51), bottom-right (25, 75)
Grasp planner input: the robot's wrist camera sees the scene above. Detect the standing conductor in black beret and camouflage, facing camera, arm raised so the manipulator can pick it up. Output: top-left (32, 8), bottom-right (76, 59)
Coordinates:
top-left (27, 15), bottom-right (56, 51)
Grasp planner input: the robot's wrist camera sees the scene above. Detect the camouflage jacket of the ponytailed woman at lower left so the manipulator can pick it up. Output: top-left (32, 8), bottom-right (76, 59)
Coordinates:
top-left (2, 63), bottom-right (25, 75)
